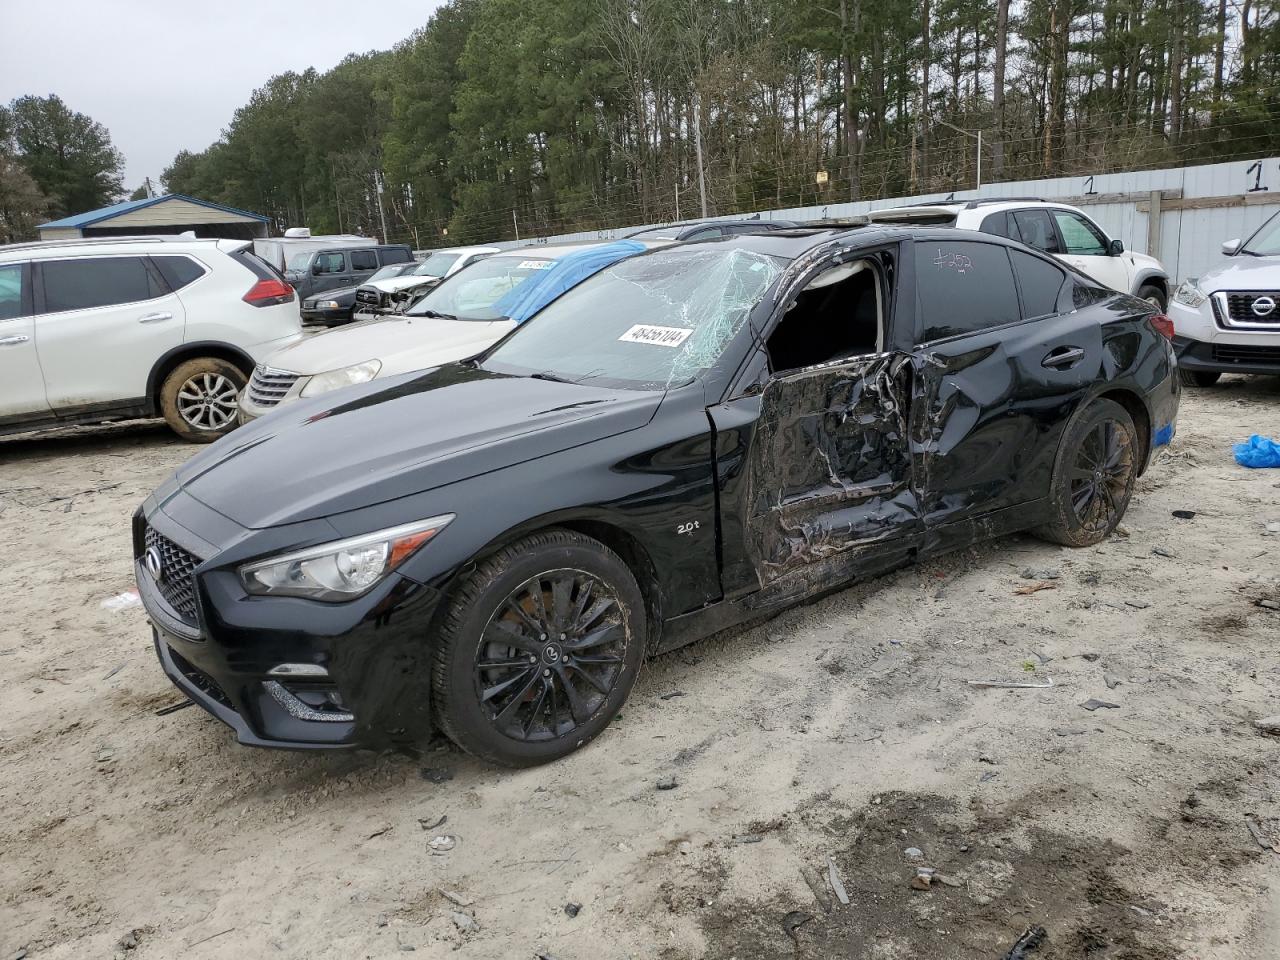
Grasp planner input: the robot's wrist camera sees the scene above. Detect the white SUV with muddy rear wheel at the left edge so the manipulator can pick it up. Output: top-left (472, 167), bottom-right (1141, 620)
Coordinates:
top-left (0, 237), bottom-right (302, 443)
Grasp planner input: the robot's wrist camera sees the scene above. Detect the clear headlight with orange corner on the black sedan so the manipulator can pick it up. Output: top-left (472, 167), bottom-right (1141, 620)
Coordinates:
top-left (239, 513), bottom-right (454, 602)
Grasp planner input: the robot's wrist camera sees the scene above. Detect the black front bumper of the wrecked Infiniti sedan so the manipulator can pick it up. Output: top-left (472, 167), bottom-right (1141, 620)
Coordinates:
top-left (134, 498), bottom-right (440, 750)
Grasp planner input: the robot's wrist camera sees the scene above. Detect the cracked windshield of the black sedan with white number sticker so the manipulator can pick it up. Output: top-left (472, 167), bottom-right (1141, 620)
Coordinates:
top-left (484, 246), bottom-right (788, 389)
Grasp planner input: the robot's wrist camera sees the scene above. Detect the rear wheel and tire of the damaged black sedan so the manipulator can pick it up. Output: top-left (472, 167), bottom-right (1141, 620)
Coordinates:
top-left (1032, 399), bottom-right (1138, 547)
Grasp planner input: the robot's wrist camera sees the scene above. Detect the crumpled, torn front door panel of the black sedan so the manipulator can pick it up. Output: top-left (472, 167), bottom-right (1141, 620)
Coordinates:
top-left (732, 353), bottom-right (920, 593)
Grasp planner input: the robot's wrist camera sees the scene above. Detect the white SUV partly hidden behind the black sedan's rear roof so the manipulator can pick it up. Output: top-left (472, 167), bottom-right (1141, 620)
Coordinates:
top-left (868, 197), bottom-right (1169, 310)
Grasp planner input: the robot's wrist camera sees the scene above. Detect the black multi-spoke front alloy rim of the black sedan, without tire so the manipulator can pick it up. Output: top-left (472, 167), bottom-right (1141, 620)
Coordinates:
top-left (475, 570), bottom-right (626, 741)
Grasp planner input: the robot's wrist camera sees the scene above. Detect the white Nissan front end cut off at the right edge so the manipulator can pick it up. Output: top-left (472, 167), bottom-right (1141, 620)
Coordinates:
top-left (1169, 214), bottom-right (1280, 387)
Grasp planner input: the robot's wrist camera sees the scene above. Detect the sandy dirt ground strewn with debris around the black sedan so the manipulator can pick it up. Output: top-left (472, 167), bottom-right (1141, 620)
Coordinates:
top-left (0, 379), bottom-right (1280, 960)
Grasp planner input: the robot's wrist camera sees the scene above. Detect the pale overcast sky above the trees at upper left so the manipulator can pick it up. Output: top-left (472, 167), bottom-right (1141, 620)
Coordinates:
top-left (0, 0), bottom-right (442, 192)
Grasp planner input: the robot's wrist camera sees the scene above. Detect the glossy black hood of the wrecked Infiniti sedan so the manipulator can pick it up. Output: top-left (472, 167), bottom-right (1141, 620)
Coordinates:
top-left (174, 364), bottom-right (663, 529)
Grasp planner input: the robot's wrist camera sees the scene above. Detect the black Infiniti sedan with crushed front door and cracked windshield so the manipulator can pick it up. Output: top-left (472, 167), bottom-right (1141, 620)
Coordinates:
top-left (133, 227), bottom-right (1179, 765)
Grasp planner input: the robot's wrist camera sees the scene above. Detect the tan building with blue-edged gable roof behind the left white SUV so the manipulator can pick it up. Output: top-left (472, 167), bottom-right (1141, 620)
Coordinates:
top-left (37, 193), bottom-right (271, 241)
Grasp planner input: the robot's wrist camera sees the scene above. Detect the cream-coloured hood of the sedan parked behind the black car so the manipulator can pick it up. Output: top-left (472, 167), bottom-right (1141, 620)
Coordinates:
top-left (254, 316), bottom-right (515, 376)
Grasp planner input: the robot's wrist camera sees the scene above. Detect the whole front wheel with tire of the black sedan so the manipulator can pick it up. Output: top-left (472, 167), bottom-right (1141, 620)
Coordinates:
top-left (431, 530), bottom-right (648, 767)
